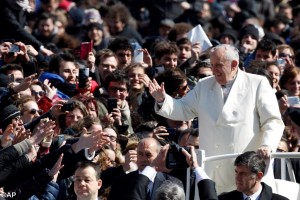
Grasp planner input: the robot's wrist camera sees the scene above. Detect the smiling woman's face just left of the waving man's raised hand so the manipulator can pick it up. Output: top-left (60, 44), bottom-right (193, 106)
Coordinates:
top-left (128, 67), bottom-right (145, 90)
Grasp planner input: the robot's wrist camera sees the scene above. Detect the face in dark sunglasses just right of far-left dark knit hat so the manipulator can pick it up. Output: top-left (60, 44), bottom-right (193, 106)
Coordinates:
top-left (21, 101), bottom-right (40, 124)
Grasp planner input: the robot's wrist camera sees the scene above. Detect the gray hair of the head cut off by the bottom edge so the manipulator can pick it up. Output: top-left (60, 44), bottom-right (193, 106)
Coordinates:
top-left (155, 181), bottom-right (185, 200)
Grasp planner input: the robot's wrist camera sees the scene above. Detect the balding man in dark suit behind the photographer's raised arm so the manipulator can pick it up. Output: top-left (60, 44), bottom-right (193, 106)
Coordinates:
top-left (108, 138), bottom-right (183, 200)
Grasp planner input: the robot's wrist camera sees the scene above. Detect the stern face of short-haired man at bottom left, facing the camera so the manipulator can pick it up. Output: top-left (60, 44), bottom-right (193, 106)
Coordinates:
top-left (74, 167), bottom-right (102, 200)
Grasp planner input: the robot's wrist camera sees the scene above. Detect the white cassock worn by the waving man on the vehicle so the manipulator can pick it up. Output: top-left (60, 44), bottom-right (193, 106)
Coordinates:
top-left (155, 70), bottom-right (284, 193)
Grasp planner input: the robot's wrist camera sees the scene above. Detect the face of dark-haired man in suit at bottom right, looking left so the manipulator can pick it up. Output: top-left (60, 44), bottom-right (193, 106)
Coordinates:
top-left (235, 165), bottom-right (260, 195)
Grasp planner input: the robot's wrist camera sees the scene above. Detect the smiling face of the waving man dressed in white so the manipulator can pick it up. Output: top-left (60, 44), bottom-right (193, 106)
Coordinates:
top-left (210, 48), bottom-right (237, 85)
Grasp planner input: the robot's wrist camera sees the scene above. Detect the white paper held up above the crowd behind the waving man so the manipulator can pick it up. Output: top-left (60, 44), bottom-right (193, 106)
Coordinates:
top-left (187, 24), bottom-right (212, 52)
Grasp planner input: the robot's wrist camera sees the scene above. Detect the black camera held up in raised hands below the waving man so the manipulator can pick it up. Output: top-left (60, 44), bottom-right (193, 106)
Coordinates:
top-left (166, 143), bottom-right (190, 169)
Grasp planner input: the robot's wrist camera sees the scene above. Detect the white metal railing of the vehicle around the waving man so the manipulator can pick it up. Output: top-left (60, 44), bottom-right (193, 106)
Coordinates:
top-left (186, 149), bottom-right (300, 200)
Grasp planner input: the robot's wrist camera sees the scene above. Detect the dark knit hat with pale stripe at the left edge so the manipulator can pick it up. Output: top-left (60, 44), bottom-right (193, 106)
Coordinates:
top-left (0, 104), bottom-right (21, 131)
